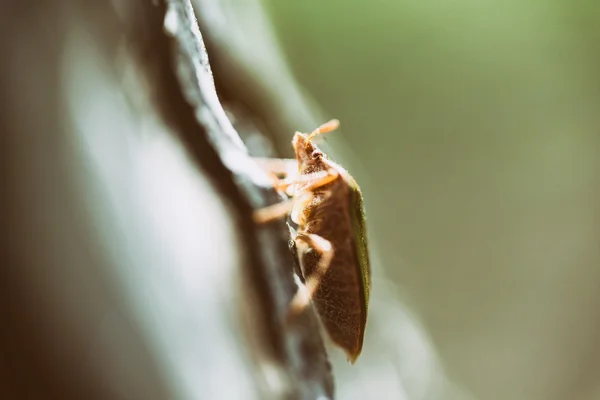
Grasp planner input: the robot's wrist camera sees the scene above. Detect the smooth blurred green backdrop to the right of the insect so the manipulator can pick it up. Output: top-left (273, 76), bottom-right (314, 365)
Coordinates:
top-left (263, 0), bottom-right (600, 400)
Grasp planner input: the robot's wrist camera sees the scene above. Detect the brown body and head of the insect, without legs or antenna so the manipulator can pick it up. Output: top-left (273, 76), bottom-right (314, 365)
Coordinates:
top-left (292, 133), bottom-right (370, 363)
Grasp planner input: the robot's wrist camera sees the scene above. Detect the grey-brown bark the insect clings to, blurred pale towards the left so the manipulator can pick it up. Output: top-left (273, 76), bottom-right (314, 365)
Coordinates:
top-left (0, 0), bottom-right (333, 399)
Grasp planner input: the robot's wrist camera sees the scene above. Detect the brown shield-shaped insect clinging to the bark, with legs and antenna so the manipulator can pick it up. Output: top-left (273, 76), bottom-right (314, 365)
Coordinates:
top-left (254, 120), bottom-right (371, 363)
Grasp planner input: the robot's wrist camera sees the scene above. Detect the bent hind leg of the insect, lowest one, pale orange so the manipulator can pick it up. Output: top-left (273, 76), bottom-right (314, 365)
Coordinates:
top-left (290, 232), bottom-right (334, 316)
